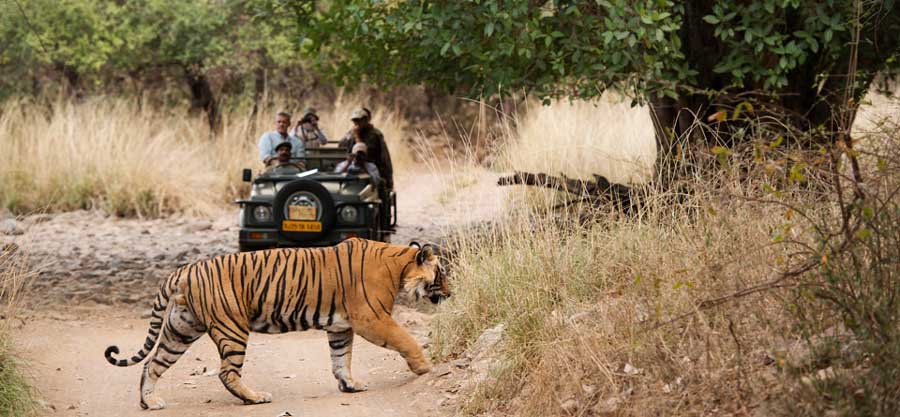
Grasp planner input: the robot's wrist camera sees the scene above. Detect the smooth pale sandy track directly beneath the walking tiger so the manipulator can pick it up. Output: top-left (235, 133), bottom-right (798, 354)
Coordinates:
top-left (14, 306), bottom-right (446, 417)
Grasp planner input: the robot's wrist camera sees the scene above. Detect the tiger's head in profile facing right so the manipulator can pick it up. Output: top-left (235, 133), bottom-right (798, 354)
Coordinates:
top-left (403, 242), bottom-right (450, 304)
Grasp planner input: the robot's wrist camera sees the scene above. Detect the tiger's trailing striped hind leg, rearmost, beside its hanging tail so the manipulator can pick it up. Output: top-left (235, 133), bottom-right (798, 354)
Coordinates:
top-left (141, 296), bottom-right (206, 410)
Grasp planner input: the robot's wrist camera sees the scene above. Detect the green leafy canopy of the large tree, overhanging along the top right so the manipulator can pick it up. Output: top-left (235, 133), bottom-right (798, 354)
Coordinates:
top-left (304, 0), bottom-right (900, 105)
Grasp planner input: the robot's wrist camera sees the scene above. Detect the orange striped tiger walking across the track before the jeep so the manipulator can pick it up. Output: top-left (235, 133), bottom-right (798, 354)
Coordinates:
top-left (104, 238), bottom-right (450, 410)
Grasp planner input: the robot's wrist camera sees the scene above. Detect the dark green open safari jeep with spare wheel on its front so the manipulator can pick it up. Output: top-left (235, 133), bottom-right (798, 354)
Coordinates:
top-left (235, 144), bottom-right (397, 252)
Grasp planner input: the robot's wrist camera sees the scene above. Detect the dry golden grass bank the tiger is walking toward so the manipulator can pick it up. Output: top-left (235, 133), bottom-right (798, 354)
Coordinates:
top-left (434, 189), bottom-right (786, 416)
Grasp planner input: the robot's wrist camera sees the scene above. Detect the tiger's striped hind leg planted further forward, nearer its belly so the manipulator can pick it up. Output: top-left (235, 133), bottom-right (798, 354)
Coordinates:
top-left (209, 323), bottom-right (272, 404)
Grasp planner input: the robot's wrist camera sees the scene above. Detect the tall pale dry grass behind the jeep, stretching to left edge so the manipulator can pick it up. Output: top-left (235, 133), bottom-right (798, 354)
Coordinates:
top-left (0, 97), bottom-right (411, 216)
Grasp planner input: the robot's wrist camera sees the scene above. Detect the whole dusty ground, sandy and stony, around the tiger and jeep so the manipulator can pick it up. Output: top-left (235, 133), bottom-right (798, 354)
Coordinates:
top-left (0, 172), bottom-right (505, 417)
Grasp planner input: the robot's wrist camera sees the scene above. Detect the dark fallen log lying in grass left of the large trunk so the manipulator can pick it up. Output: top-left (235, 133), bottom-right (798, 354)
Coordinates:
top-left (497, 171), bottom-right (639, 214)
